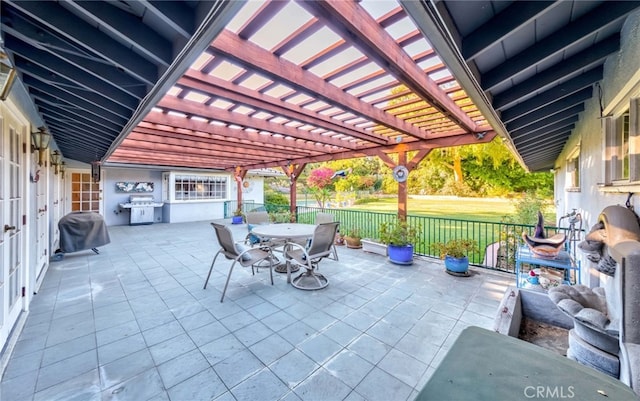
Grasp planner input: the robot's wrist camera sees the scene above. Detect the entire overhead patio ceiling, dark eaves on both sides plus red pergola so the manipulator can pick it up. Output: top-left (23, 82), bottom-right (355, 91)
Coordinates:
top-left (0, 0), bottom-right (639, 170)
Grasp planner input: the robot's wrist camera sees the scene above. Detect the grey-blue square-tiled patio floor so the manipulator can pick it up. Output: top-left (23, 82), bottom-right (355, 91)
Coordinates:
top-left (0, 221), bottom-right (514, 401)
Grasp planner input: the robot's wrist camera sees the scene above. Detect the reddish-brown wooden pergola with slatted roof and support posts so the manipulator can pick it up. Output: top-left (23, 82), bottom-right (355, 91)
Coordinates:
top-left (101, 1), bottom-right (495, 217)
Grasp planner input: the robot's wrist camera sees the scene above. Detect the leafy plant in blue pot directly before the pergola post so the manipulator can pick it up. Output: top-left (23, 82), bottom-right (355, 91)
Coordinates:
top-left (379, 219), bottom-right (419, 265)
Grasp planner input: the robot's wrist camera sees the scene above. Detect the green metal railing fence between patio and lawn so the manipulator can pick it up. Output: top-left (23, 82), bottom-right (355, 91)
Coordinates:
top-left (225, 204), bottom-right (575, 273)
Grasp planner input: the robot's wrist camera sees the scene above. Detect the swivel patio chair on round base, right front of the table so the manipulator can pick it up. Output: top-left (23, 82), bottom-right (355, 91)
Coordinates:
top-left (284, 221), bottom-right (340, 290)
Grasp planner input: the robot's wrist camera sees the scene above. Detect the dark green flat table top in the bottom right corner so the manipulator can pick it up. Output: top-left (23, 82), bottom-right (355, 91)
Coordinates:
top-left (415, 327), bottom-right (638, 401)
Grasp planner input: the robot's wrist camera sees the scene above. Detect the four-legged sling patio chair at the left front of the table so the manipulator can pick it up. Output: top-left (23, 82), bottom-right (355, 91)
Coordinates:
top-left (204, 223), bottom-right (273, 302)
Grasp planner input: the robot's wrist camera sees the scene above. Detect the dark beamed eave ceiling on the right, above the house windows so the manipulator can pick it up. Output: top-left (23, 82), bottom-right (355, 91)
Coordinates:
top-left (402, 0), bottom-right (640, 171)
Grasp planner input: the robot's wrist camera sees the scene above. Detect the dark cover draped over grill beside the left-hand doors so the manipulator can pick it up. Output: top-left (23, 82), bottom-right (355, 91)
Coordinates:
top-left (58, 212), bottom-right (111, 253)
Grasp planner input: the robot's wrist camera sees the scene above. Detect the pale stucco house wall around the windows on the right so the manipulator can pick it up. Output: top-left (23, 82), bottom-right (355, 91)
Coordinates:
top-left (555, 12), bottom-right (640, 286)
